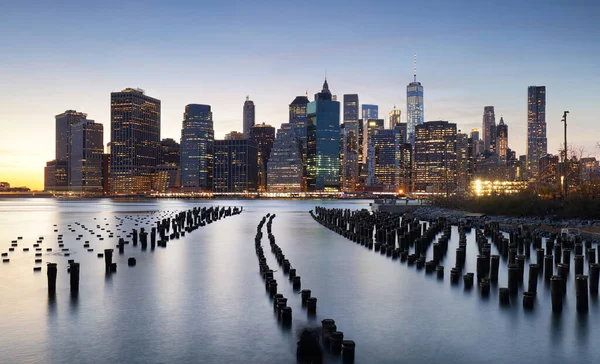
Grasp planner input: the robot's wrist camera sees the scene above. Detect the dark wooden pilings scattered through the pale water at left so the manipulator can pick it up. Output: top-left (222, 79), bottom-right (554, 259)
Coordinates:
top-left (41, 207), bottom-right (243, 297)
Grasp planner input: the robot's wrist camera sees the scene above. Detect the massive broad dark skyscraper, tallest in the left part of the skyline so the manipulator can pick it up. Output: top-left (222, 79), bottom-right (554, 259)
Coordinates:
top-left (110, 88), bottom-right (160, 193)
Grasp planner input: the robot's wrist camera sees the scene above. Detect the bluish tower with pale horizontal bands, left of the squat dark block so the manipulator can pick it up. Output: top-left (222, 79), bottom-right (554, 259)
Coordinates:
top-left (180, 104), bottom-right (215, 192)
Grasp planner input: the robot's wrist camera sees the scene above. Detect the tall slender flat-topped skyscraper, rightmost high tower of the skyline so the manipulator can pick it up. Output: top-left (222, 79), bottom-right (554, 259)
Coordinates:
top-left (527, 86), bottom-right (548, 179)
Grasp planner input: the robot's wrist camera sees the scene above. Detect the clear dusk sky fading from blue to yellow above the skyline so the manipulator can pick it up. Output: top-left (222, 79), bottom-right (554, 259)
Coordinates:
top-left (0, 0), bottom-right (600, 189)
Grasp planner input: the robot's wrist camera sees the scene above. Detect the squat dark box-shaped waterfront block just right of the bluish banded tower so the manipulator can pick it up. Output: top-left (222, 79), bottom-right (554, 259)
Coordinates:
top-left (213, 139), bottom-right (258, 193)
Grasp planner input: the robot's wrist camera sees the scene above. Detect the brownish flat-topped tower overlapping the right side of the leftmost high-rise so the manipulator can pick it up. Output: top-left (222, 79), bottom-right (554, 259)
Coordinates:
top-left (70, 120), bottom-right (104, 194)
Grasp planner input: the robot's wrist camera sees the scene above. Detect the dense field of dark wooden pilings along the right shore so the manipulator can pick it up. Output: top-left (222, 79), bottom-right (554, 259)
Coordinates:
top-left (310, 207), bottom-right (600, 312)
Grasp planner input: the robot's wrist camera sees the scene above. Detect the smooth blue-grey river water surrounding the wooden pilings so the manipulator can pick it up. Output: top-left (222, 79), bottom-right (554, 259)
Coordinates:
top-left (0, 199), bottom-right (600, 363)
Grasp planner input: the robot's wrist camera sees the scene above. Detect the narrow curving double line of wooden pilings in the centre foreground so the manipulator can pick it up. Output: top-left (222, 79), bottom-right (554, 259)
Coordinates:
top-left (255, 214), bottom-right (356, 363)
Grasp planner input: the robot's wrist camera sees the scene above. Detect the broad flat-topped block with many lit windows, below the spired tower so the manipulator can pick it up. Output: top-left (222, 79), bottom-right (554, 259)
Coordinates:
top-left (413, 121), bottom-right (457, 194)
